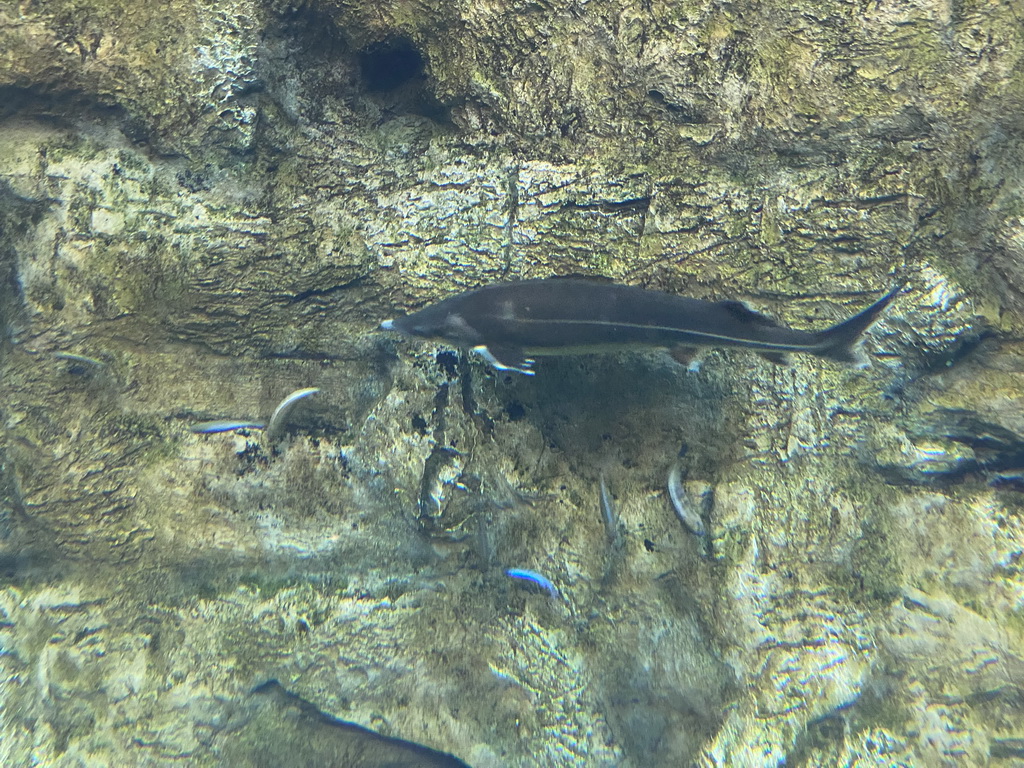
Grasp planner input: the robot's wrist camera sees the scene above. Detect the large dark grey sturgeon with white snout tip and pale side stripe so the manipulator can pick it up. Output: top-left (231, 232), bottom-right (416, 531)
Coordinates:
top-left (381, 278), bottom-right (900, 374)
